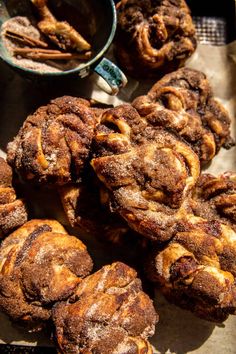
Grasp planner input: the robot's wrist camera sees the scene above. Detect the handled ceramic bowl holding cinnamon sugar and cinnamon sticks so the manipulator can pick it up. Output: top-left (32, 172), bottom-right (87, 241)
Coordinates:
top-left (0, 0), bottom-right (126, 94)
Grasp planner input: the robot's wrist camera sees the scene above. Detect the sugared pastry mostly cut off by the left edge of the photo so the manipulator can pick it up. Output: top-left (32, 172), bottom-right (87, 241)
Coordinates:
top-left (0, 157), bottom-right (27, 238)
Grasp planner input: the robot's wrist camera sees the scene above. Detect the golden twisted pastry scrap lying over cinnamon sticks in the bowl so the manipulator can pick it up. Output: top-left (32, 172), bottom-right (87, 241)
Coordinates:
top-left (31, 0), bottom-right (91, 52)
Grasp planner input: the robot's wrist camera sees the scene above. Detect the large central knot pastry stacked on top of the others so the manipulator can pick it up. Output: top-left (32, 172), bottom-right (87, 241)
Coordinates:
top-left (91, 104), bottom-right (199, 241)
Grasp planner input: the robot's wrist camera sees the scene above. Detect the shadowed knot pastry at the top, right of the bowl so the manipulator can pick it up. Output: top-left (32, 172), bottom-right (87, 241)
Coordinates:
top-left (115, 0), bottom-right (197, 78)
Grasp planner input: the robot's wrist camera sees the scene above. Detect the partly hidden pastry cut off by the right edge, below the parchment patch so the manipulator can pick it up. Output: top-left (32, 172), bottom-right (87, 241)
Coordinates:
top-left (192, 172), bottom-right (236, 231)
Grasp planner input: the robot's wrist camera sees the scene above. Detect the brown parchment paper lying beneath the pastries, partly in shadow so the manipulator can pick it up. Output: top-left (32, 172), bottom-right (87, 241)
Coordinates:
top-left (0, 41), bottom-right (236, 354)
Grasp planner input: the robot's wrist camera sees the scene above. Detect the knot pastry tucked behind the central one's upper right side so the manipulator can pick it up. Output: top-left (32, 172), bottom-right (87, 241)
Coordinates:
top-left (133, 68), bottom-right (233, 164)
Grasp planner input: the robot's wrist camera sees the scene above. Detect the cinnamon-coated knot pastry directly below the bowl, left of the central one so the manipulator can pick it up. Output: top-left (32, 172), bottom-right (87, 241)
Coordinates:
top-left (7, 96), bottom-right (97, 185)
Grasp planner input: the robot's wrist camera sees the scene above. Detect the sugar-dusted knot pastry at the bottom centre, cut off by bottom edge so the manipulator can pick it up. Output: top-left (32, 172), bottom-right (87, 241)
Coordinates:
top-left (53, 262), bottom-right (158, 354)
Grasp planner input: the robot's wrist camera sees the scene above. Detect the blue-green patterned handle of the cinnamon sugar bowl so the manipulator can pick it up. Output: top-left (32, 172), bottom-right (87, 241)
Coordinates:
top-left (93, 58), bottom-right (127, 95)
